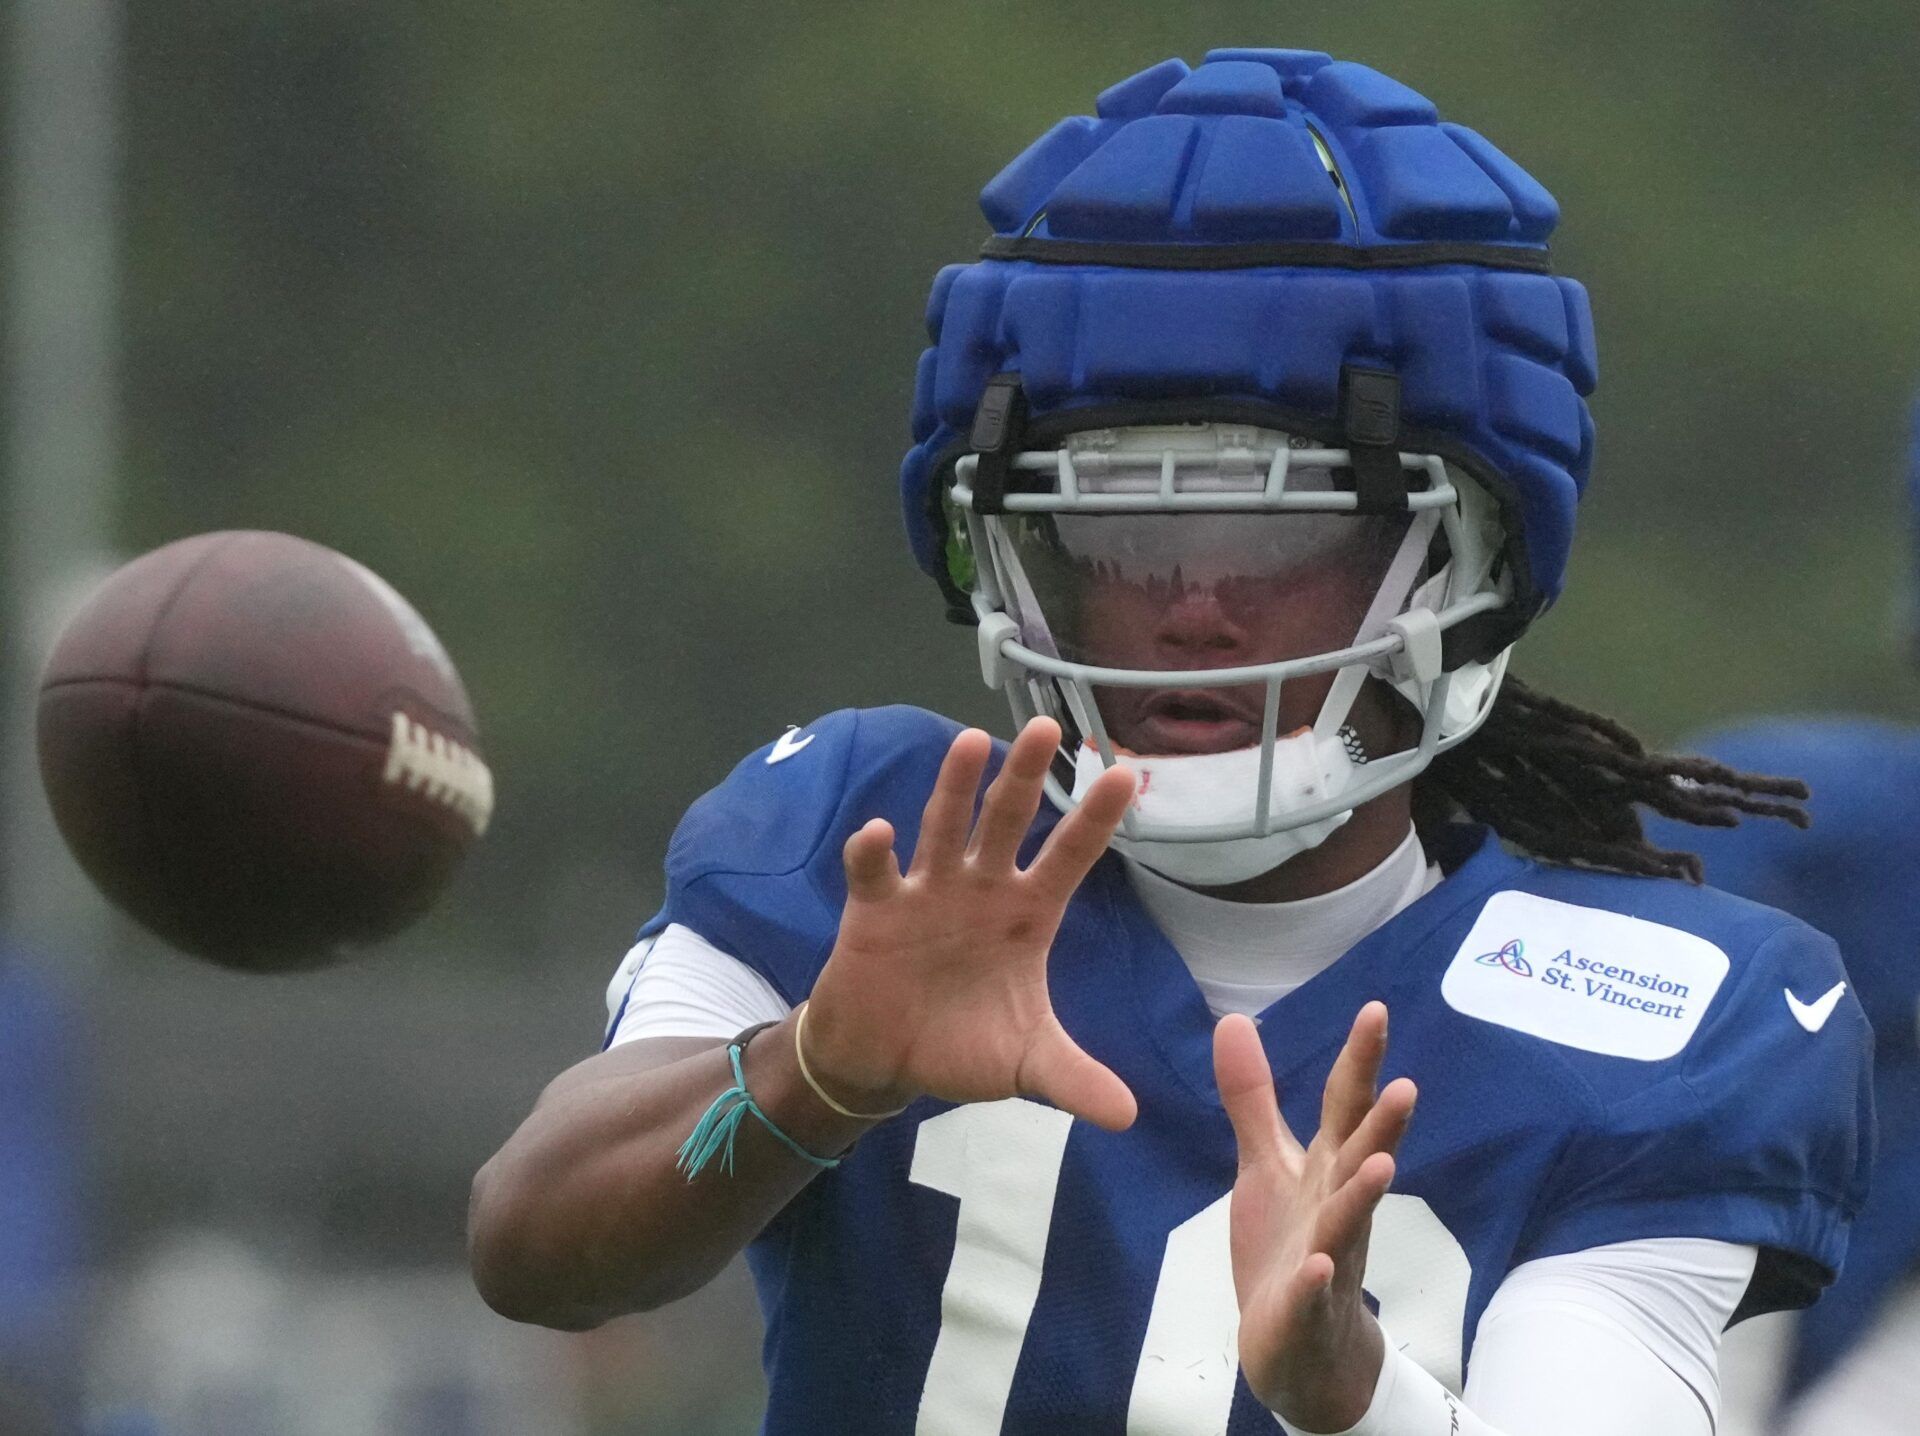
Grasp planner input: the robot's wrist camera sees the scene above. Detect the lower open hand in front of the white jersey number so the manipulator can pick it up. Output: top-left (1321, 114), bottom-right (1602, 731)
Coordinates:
top-left (1213, 1002), bottom-right (1415, 1430)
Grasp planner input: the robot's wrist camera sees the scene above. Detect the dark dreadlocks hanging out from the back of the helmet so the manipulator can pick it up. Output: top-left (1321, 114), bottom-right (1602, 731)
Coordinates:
top-left (1413, 674), bottom-right (1809, 883)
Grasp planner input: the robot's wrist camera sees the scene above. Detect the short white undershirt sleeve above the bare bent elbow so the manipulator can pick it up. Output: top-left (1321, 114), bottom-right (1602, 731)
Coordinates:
top-left (607, 923), bottom-right (791, 1048)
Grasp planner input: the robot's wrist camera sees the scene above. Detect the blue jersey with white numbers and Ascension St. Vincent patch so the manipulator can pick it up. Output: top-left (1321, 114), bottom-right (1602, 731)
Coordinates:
top-left (629, 708), bottom-right (1872, 1436)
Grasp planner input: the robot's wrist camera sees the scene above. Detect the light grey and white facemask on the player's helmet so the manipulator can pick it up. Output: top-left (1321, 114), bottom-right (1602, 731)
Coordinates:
top-left (954, 424), bottom-right (1511, 887)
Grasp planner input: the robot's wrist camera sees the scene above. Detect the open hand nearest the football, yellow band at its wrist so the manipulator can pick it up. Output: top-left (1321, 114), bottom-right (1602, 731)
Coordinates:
top-left (804, 718), bottom-right (1137, 1129)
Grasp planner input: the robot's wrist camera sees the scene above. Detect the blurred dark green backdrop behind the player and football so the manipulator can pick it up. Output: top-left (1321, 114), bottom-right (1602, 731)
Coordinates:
top-left (12, 0), bottom-right (1920, 1436)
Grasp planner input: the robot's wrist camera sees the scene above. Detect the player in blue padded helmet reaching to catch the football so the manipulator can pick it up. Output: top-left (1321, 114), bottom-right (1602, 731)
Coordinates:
top-left (472, 50), bottom-right (1870, 1436)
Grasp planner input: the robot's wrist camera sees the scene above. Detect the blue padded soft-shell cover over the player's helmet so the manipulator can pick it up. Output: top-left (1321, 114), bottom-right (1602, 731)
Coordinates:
top-left (900, 50), bottom-right (1596, 622)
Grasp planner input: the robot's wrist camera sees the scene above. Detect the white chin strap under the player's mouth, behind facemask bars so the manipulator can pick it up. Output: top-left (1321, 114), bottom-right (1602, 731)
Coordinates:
top-left (1071, 511), bottom-right (1440, 887)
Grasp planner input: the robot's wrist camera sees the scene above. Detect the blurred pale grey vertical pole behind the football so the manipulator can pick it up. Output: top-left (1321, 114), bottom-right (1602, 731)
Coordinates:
top-left (0, 0), bottom-right (119, 969)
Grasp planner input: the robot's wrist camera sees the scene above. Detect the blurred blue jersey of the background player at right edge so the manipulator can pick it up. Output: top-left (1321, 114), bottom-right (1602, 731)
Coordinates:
top-left (1651, 718), bottom-right (1920, 1394)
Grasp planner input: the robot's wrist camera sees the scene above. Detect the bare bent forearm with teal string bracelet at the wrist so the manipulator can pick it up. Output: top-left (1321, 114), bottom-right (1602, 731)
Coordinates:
top-left (468, 1023), bottom-right (866, 1330)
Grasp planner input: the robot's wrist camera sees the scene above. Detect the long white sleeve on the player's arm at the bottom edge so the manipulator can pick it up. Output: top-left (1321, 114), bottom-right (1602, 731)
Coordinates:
top-left (1281, 1236), bottom-right (1759, 1436)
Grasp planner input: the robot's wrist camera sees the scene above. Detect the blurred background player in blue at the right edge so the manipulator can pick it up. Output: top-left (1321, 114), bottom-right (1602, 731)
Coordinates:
top-left (1655, 393), bottom-right (1920, 1436)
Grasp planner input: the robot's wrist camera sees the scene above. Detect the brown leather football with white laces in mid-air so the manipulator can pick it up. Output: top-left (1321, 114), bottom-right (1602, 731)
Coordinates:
top-left (38, 532), bottom-right (493, 971)
